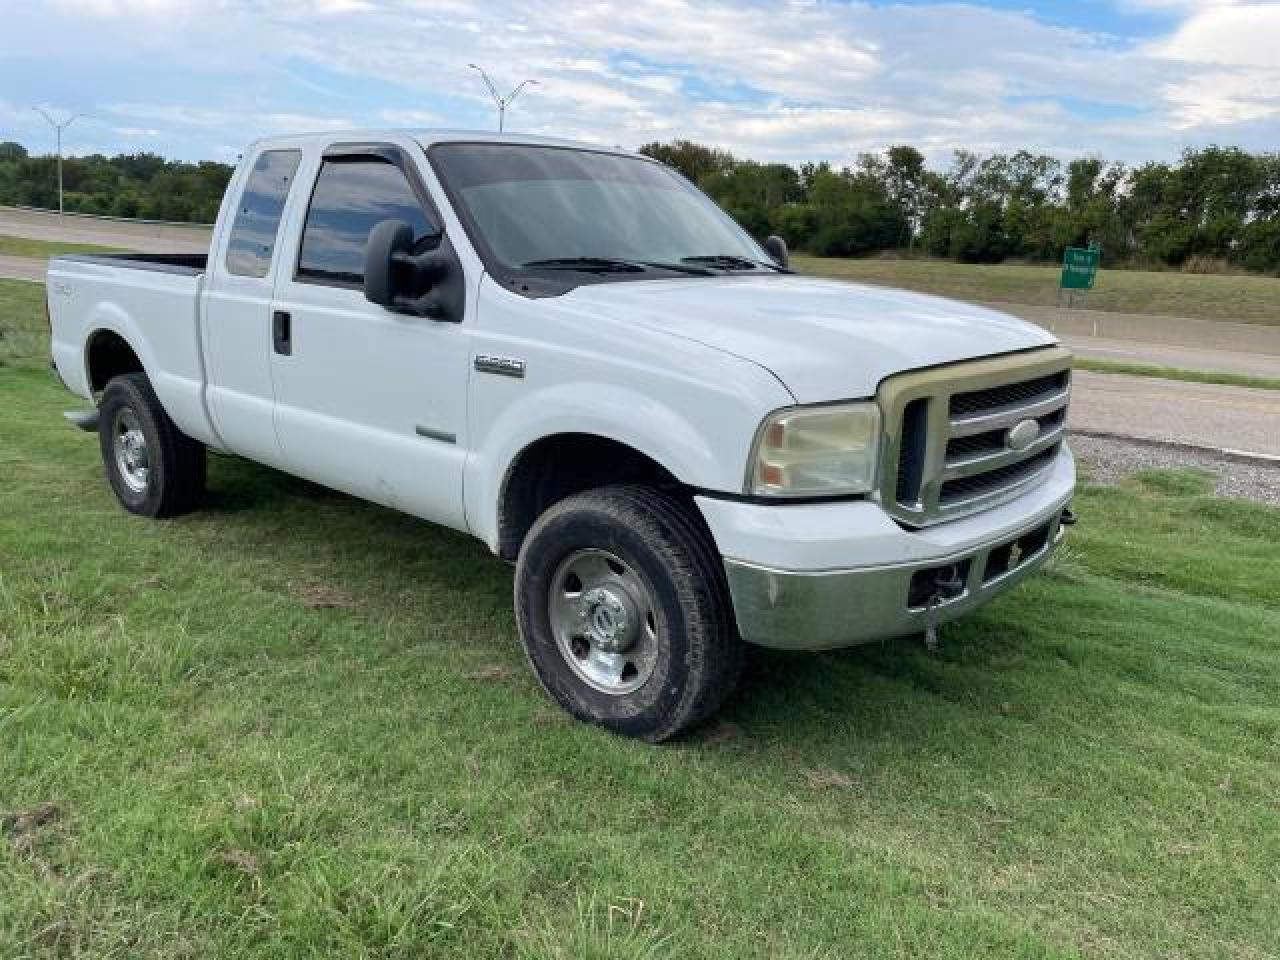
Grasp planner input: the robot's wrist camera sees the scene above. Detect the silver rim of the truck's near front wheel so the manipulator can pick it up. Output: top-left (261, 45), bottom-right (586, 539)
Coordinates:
top-left (548, 549), bottom-right (658, 696)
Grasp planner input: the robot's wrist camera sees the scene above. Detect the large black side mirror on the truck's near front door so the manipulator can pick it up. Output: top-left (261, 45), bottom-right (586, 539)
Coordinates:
top-left (365, 220), bottom-right (465, 323)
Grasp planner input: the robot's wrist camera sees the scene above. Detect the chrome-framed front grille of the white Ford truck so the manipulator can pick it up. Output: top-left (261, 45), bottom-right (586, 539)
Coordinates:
top-left (877, 347), bottom-right (1071, 526)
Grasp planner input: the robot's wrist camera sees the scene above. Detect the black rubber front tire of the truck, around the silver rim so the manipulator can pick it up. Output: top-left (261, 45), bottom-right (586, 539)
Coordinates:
top-left (516, 486), bottom-right (744, 742)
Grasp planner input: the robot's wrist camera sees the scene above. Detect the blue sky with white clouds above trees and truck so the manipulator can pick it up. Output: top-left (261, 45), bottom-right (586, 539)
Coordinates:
top-left (0, 0), bottom-right (1280, 164)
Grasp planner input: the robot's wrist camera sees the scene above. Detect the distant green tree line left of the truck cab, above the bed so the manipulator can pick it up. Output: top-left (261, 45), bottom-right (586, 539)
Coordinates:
top-left (0, 141), bottom-right (232, 223)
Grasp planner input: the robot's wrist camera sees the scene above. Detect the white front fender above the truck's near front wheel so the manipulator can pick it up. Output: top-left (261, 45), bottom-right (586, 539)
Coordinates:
top-left (463, 271), bottom-right (795, 550)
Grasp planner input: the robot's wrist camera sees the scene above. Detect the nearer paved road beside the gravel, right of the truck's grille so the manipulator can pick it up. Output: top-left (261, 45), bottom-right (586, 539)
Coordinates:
top-left (1069, 370), bottom-right (1280, 456)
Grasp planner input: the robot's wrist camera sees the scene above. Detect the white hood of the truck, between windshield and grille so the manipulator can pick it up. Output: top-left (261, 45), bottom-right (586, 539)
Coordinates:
top-left (564, 275), bottom-right (1057, 403)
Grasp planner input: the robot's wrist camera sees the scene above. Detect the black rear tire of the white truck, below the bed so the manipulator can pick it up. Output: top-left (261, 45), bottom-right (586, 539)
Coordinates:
top-left (97, 374), bottom-right (206, 517)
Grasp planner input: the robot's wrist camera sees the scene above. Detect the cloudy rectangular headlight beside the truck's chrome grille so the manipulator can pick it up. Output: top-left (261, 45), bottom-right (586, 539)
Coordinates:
top-left (746, 402), bottom-right (881, 497)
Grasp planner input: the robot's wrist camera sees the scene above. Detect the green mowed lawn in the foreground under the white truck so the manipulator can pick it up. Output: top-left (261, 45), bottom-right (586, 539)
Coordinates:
top-left (0, 283), bottom-right (1280, 960)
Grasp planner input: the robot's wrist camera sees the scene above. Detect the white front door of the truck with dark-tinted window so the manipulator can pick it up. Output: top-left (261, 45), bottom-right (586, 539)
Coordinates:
top-left (271, 145), bottom-right (470, 529)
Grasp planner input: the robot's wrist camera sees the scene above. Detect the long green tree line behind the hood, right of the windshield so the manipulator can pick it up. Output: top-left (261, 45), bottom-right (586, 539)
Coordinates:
top-left (640, 141), bottom-right (1280, 274)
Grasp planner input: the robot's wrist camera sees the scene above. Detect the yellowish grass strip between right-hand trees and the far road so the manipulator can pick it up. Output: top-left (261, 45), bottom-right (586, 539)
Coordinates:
top-left (792, 256), bottom-right (1280, 324)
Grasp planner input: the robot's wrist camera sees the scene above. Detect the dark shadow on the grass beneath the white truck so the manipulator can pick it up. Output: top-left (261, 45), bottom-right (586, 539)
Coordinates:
top-left (197, 458), bottom-right (1064, 749)
